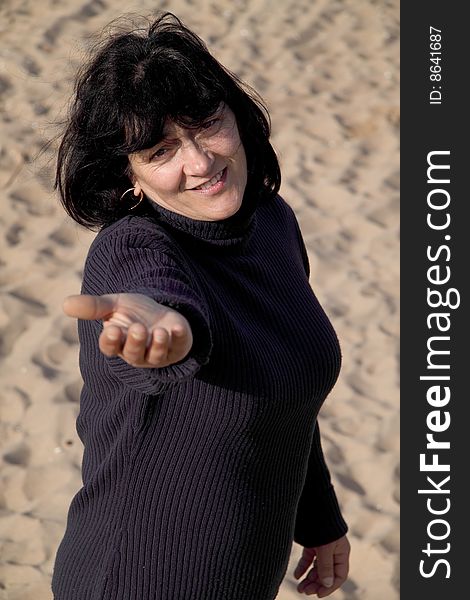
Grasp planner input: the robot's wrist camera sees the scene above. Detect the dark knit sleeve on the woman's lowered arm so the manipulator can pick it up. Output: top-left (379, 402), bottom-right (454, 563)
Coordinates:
top-left (294, 421), bottom-right (348, 548)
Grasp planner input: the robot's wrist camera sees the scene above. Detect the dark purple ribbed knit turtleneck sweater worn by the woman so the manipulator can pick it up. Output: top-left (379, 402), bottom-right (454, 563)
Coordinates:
top-left (52, 197), bottom-right (347, 600)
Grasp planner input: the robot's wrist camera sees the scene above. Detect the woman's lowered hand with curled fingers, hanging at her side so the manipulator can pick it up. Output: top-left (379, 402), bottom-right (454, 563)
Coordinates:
top-left (294, 536), bottom-right (351, 598)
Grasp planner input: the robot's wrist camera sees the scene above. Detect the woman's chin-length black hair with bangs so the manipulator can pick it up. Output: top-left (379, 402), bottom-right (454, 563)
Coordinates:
top-left (55, 12), bottom-right (281, 229)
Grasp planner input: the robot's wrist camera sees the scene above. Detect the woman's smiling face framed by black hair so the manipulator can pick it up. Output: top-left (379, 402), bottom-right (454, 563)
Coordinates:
top-left (129, 104), bottom-right (247, 221)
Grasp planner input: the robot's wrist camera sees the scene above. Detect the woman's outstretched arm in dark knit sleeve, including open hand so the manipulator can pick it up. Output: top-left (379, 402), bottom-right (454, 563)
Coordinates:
top-left (69, 217), bottom-right (212, 395)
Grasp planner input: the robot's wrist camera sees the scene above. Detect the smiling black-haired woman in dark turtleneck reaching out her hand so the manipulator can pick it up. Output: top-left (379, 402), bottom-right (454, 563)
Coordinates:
top-left (53, 13), bottom-right (349, 600)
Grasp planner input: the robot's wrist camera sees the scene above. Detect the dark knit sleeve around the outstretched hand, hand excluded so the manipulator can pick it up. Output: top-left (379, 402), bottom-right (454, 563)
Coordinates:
top-left (82, 218), bottom-right (212, 394)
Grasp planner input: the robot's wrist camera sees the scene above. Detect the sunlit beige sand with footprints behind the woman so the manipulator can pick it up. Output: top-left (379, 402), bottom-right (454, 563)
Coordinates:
top-left (0, 0), bottom-right (399, 600)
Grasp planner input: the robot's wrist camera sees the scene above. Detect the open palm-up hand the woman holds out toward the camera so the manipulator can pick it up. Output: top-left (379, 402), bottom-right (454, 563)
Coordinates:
top-left (63, 294), bottom-right (193, 368)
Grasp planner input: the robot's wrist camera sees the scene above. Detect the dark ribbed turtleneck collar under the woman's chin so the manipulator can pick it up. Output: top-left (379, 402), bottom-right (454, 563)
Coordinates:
top-left (147, 195), bottom-right (259, 247)
